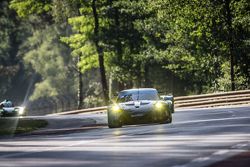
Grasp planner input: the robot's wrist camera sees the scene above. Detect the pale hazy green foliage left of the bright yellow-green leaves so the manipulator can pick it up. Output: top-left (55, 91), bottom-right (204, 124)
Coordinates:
top-left (20, 26), bottom-right (75, 100)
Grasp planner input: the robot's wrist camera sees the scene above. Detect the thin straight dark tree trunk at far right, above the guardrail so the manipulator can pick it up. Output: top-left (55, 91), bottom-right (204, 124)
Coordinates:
top-left (225, 0), bottom-right (235, 91)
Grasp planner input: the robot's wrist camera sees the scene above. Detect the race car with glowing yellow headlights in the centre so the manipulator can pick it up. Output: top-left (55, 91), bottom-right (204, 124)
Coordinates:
top-left (108, 88), bottom-right (172, 128)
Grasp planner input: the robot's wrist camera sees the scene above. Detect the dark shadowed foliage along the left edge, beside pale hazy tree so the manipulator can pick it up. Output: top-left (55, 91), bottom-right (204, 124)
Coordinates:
top-left (0, 0), bottom-right (32, 97)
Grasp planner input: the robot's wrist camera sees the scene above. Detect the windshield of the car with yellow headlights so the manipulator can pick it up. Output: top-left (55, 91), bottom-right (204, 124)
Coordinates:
top-left (117, 90), bottom-right (159, 103)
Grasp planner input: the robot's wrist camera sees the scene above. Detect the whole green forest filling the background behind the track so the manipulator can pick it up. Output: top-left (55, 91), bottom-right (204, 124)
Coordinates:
top-left (0, 0), bottom-right (250, 108)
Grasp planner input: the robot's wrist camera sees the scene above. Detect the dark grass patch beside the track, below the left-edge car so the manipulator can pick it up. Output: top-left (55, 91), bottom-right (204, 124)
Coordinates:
top-left (0, 118), bottom-right (48, 136)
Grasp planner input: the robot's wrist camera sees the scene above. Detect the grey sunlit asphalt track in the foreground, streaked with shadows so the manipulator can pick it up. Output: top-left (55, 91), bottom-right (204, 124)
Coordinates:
top-left (0, 107), bottom-right (250, 167)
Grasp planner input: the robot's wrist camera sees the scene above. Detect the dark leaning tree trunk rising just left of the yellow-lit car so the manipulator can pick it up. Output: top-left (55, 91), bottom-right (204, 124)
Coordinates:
top-left (92, 0), bottom-right (109, 104)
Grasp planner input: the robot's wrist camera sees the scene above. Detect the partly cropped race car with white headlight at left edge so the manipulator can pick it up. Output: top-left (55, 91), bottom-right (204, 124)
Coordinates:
top-left (0, 100), bottom-right (24, 117)
